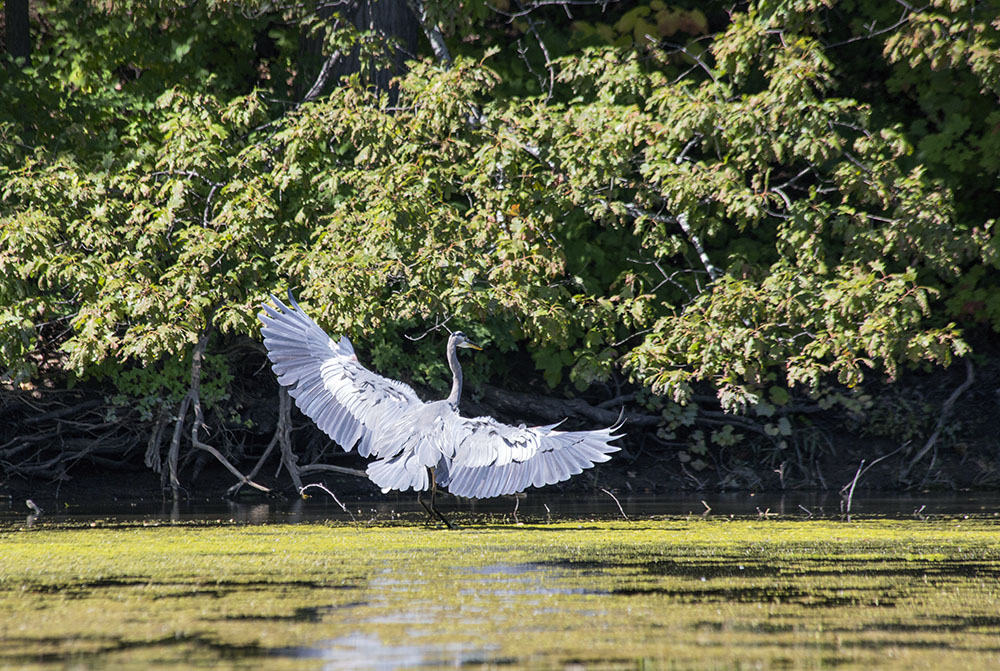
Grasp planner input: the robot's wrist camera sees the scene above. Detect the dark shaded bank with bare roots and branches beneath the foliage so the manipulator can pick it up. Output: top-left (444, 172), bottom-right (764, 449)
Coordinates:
top-left (0, 342), bottom-right (1000, 498)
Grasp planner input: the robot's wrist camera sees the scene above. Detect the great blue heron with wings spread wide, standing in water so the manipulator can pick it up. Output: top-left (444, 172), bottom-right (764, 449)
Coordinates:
top-left (260, 291), bottom-right (623, 526)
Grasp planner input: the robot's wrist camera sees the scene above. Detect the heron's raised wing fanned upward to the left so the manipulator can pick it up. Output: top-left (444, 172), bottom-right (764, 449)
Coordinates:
top-left (260, 291), bottom-right (422, 457)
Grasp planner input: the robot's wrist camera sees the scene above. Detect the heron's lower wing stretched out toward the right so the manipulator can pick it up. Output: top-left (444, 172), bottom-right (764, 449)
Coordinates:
top-left (438, 413), bottom-right (624, 498)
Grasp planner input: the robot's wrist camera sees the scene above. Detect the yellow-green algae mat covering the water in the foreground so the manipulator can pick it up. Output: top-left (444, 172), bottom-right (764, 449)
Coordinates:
top-left (0, 518), bottom-right (1000, 670)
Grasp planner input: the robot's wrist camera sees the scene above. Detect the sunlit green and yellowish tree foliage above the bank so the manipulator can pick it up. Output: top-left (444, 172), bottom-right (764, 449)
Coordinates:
top-left (0, 0), bottom-right (1000, 490)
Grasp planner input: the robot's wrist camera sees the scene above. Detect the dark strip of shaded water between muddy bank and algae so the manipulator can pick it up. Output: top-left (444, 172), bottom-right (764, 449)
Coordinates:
top-left (0, 490), bottom-right (1000, 525)
